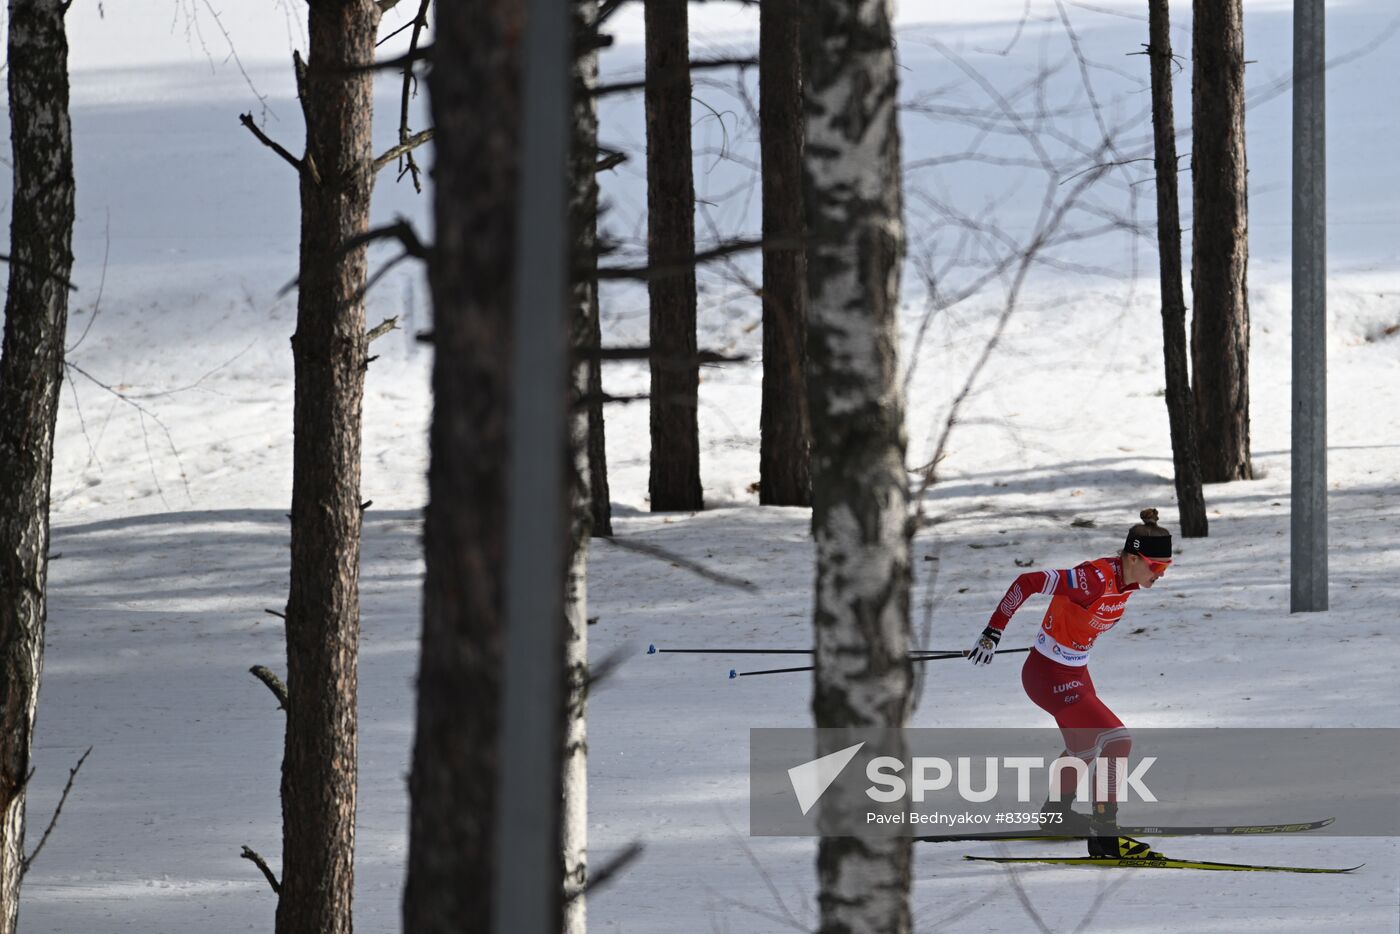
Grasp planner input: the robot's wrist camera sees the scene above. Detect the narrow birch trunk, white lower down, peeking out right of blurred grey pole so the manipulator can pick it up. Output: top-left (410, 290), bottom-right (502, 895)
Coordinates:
top-left (560, 0), bottom-right (606, 934)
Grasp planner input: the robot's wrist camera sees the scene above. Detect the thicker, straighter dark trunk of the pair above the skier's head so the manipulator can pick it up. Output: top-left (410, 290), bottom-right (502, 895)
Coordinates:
top-left (1191, 0), bottom-right (1252, 483)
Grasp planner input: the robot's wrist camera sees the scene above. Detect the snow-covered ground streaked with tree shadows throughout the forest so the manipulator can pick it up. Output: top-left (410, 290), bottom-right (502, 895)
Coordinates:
top-left (2, 0), bottom-right (1400, 934)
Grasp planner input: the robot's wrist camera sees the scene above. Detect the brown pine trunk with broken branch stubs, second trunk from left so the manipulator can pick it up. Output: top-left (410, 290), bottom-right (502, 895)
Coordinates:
top-left (277, 0), bottom-right (379, 934)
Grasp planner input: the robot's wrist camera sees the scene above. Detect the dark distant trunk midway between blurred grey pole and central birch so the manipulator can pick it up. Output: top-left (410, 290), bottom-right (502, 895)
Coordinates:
top-left (645, 0), bottom-right (704, 513)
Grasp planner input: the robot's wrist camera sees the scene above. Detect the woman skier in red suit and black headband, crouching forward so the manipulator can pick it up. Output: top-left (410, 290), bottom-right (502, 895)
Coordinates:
top-left (969, 510), bottom-right (1172, 858)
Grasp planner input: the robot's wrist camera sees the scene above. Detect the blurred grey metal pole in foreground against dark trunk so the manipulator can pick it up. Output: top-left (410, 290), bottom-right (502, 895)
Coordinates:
top-left (498, 0), bottom-right (571, 934)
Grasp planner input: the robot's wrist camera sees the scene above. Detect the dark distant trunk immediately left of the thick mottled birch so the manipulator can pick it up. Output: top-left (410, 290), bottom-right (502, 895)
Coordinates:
top-left (759, 0), bottom-right (812, 506)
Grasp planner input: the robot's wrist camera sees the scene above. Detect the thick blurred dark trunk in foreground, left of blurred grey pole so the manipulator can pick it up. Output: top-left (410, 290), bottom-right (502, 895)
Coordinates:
top-left (403, 0), bottom-right (525, 934)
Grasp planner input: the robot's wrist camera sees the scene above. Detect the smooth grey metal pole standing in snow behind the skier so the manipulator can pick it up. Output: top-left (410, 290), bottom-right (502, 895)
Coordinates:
top-left (1291, 0), bottom-right (1327, 613)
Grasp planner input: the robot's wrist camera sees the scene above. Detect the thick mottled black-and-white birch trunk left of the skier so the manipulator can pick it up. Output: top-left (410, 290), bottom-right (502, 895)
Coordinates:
top-left (802, 0), bottom-right (911, 934)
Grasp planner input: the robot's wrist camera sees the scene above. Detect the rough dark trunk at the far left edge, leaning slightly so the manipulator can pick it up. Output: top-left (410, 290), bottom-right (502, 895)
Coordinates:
top-left (0, 0), bottom-right (74, 934)
